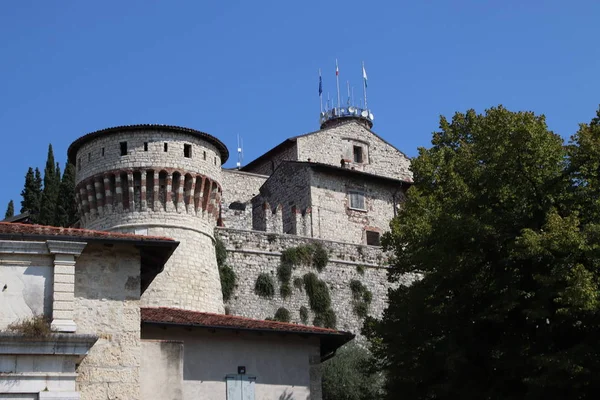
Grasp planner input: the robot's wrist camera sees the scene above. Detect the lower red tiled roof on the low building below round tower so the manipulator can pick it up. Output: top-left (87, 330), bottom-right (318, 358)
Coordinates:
top-left (141, 307), bottom-right (352, 336)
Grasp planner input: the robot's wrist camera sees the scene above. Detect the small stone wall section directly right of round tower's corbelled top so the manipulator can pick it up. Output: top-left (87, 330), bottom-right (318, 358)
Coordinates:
top-left (221, 170), bottom-right (268, 229)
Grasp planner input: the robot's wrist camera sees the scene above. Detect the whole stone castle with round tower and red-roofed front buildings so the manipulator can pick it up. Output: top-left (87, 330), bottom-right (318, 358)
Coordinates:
top-left (0, 107), bottom-right (412, 399)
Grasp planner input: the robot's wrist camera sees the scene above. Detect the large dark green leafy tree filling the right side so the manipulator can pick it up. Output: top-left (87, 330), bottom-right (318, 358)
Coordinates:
top-left (364, 107), bottom-right (600, 399)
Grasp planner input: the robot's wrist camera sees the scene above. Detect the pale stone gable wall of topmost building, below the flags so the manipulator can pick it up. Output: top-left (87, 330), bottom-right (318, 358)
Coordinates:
top-left (296, 121), bottom-right (412, 181)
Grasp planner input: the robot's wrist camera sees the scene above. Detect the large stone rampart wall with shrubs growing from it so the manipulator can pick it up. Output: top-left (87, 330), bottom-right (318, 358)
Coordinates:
top-left (215, 228), bottom-right (412, 334)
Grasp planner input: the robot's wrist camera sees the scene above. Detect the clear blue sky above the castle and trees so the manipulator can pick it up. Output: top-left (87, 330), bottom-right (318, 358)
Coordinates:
top-left (0, 0), bottom-right (600, 216)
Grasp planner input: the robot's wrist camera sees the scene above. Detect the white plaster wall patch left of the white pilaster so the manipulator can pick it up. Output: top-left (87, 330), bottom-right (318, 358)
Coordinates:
top-left (0, 254), bottom-right (54, 331)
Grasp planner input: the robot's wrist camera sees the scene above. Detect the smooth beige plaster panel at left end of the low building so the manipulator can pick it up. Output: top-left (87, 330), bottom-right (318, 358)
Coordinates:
top-left (140, 340), bottom-right (183, 400)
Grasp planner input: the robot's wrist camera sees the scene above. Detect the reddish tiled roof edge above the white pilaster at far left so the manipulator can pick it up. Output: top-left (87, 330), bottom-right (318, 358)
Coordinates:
top-left (0, 222), bottom-right (174, 242)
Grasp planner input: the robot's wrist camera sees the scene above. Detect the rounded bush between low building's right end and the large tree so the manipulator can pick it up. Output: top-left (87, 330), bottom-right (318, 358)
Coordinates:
top-left (323, 342), bottom-right (383, 400)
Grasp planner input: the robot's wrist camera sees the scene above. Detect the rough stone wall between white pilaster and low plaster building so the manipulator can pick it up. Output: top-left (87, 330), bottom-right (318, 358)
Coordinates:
top-left (74, 244), bottom-right (141, 400)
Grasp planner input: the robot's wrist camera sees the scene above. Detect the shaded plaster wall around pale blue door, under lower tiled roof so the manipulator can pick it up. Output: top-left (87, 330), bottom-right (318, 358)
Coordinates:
top-left (142, 325), bottom-right (320, 400)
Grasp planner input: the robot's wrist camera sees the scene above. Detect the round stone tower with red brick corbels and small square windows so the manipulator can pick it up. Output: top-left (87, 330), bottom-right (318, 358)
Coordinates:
top-left (68, 125), bottom-right (229, 313)
